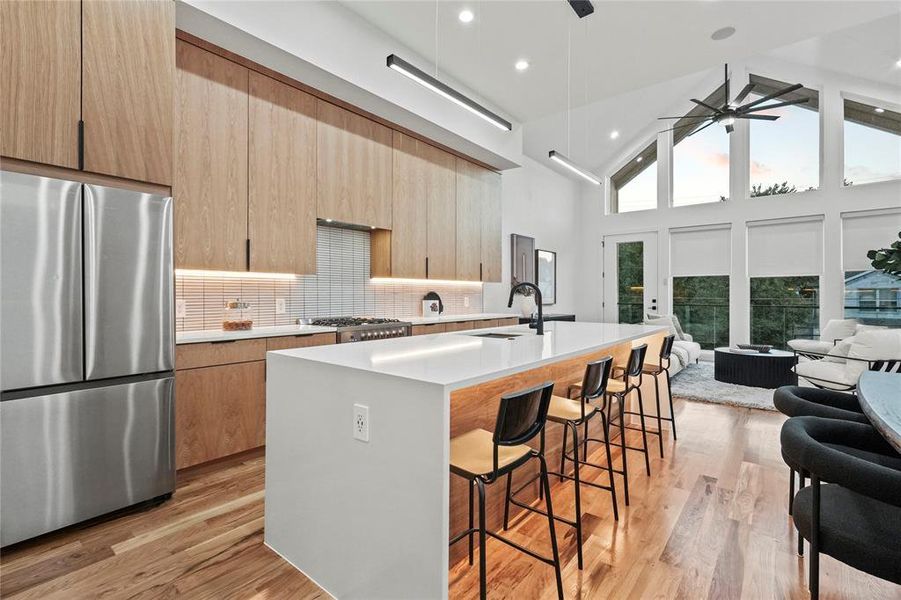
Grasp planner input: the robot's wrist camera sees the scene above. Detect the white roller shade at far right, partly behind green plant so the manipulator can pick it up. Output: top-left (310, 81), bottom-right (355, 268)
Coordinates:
top-left (842, 209), bottom-right (901, 271)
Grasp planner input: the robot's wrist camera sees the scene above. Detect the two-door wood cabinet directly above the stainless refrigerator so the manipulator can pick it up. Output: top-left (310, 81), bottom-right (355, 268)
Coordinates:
top-left (0, 0), bottom-right (175, 185)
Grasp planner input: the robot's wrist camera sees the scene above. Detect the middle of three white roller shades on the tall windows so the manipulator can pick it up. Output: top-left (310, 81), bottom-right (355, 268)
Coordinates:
top-left (748, 216), bottom-right (823, 277)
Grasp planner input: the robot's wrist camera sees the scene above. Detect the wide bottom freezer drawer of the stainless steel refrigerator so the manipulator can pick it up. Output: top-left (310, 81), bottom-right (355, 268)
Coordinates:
top-left (0, 377), bottom-right (175, 546)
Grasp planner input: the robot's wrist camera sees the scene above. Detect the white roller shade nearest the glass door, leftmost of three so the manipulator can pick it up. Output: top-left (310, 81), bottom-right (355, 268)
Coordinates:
top-left (670, 225), bottom-right (732, 277)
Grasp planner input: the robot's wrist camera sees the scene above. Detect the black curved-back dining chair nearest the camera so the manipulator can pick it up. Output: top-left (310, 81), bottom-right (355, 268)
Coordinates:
top-left (781, 417), bottom-right (901, 600)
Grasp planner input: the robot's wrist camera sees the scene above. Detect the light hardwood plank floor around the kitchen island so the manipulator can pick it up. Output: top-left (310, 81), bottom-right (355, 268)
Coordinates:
top-left (0, 401), bottom-right (901, 599)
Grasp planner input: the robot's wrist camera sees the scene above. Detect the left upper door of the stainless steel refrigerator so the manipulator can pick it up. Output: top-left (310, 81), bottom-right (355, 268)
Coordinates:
top-left (0, 171), bottom-right (83, 390)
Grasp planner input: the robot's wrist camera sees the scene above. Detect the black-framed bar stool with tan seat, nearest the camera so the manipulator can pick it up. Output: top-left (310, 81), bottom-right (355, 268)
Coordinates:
top-left (450, 381), bottom-right (563, 600)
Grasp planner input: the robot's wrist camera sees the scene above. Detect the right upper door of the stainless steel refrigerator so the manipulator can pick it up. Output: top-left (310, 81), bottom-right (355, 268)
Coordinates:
top-left (84, 185), bottom-right (175, 379)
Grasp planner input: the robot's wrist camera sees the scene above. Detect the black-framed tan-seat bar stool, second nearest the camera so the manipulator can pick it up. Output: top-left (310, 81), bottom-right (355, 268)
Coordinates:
top-left (504, 356), bottom-right (619, 569)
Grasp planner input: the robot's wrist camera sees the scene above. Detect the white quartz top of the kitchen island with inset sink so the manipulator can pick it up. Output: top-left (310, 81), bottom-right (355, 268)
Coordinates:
top-left (270, 321), bottom-right (665, 388)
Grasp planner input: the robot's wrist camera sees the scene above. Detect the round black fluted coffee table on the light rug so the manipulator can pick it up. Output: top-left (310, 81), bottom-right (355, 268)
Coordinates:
top-left (713, 348), bottom-right (798, 388)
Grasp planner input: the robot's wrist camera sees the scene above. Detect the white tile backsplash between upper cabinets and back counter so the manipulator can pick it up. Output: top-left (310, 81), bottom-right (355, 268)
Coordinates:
top-left (175, 226), bottom-right (482, 331)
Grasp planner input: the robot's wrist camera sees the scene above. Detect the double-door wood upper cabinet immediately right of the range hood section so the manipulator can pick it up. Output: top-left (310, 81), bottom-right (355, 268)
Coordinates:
top-left (390, 131), bottom-right (456, 279)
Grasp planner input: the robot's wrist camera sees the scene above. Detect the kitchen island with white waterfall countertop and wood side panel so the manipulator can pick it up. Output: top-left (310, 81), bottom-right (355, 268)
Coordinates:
top-left (265, 322), bottom-right (669, 598)
